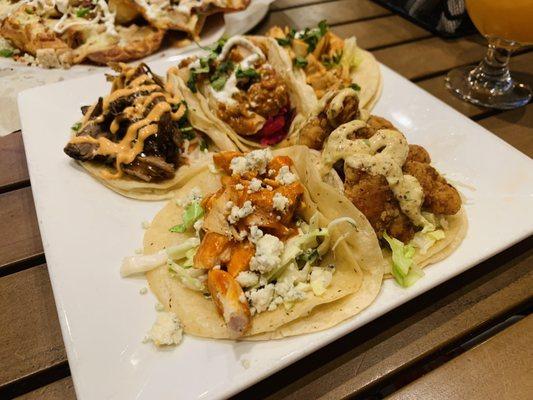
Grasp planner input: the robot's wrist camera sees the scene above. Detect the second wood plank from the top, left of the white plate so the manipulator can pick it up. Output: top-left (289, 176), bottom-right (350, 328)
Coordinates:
top-left (0, 187), bottom-right (43, 271)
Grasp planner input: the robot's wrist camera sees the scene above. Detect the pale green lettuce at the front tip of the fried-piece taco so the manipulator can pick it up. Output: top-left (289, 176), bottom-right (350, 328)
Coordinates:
top-left (383, 232), bottom-right (423, 287)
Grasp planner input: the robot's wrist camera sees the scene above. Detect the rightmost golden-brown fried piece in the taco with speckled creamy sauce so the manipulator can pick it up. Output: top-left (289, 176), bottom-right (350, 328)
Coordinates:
top-left (403, 161), bottom-right (461, 215)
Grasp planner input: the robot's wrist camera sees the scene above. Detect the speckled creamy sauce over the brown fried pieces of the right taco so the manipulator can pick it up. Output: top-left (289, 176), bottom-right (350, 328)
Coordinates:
top-left (322, 120), bottom-right (434, 230)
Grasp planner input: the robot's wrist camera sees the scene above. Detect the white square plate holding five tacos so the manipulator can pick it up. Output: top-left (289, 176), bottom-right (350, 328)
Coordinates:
top-left (19, 57), bottom-right (533, 400)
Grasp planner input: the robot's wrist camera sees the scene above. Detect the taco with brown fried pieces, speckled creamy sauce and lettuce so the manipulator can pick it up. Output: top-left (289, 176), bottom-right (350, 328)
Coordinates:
top-left (320, 113), bottom-right (467, 286)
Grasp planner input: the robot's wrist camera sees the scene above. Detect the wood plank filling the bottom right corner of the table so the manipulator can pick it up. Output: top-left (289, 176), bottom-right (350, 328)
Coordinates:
top-left (387, 315), bottom-right (533, 400)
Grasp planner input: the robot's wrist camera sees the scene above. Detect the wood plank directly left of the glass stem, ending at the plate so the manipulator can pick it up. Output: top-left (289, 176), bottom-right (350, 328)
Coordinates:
top-left (373, 36), bottom-right (485, 79)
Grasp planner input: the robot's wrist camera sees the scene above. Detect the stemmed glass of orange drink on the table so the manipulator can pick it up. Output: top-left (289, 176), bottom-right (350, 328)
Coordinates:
top-left (446, 0), bottom-right (533, 109)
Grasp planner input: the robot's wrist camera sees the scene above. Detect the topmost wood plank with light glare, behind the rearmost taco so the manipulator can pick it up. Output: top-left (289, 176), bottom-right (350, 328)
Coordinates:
top-left (254, 0), bottom-right (391, 33)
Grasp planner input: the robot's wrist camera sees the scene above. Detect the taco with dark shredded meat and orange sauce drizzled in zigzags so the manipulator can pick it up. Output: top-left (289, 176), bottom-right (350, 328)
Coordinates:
top-left (64, 64), bottom-right (234, 200)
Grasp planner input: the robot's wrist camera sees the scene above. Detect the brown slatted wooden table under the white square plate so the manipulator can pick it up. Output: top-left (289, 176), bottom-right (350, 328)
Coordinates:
top-left (0, 0), bottom-right (533, 399)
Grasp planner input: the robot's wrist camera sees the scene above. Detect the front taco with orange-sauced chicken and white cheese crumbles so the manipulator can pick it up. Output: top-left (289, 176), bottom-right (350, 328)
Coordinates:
top-left (121, 146), bottom-right (383, 340)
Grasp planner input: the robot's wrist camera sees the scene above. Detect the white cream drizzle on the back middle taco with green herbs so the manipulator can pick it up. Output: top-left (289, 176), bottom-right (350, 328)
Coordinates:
top-left (209, 36), bottom-right (266, 105)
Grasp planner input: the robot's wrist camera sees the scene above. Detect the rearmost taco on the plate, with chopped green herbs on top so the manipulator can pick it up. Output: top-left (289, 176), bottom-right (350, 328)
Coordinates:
top-left (267, 21), bottom-right (381, 110)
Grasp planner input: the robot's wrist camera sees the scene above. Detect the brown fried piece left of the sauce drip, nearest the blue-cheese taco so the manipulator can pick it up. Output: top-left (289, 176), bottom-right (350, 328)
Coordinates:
top-left (344, 165), bottom-right (415, 243)
